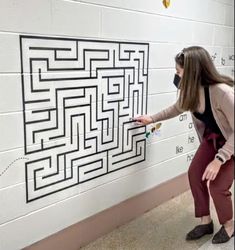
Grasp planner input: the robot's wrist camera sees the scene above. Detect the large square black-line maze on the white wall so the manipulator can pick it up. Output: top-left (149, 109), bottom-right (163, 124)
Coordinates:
top-left (20, 36), bottom-right (149, 202)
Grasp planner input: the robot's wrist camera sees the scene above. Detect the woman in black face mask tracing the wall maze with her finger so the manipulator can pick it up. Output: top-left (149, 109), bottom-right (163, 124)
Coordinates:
top-left (135, 46), bottom-right (234, 244)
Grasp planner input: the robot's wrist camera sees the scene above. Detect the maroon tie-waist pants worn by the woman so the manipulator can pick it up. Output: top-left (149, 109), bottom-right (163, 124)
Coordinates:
top-left (188, 130), bottom-right (234, 225)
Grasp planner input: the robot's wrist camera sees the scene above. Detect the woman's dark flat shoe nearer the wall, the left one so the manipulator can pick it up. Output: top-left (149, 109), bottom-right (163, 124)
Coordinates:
top-left (186, 221), bottom-right (214, 240)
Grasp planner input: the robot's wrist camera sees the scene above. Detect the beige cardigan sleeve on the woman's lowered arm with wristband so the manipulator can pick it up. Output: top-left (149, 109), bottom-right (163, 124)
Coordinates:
top-left (216, 91), bottom-right (234, 162)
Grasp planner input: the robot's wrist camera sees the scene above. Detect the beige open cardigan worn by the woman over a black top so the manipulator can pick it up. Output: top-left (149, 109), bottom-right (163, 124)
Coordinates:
top-left (151, 83), bottom-right (234, 162)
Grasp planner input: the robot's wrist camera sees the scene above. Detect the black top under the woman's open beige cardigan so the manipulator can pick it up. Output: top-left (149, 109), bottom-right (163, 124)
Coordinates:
top-left (193, 87), bottom-right (222, 134)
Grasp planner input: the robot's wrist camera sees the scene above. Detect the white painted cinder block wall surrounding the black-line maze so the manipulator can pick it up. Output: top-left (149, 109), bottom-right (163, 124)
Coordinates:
top-left (0, 0), bottom-right (234, 250)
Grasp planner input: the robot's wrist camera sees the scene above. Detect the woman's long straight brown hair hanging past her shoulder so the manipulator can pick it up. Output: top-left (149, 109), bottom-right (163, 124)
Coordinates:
top-left (175, 46), bottom-right (234, 112)
